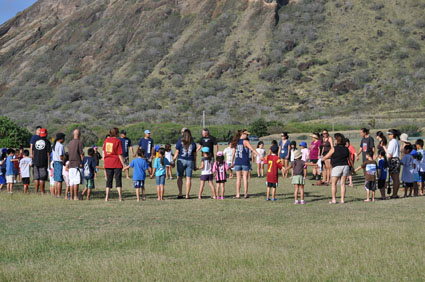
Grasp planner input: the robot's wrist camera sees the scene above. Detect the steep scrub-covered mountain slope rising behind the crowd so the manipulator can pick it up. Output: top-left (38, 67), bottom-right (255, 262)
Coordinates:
top-left (0, 0), bottom-right (425, 130)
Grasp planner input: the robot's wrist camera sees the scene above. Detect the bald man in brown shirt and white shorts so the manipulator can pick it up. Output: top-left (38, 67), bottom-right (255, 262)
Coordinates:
top-left (68, 129), bottom-right (84, 201)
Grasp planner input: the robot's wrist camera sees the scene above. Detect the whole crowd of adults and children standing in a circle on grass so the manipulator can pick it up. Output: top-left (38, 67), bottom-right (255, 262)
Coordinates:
top-left (0, 127), bottom-right (425, 204)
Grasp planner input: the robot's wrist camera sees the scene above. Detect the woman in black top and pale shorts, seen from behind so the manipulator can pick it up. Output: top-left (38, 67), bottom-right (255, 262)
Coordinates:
top-left (323, 133), bottom-right (352, 204)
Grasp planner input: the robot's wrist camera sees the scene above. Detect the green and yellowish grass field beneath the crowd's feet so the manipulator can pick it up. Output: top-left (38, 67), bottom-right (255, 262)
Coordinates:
top-left (0, 144), bottom-right (425, 281)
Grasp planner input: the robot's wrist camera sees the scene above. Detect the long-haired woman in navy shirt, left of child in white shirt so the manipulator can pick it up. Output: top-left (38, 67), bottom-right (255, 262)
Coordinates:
top-left (173, 129), bottom-right (196, 199)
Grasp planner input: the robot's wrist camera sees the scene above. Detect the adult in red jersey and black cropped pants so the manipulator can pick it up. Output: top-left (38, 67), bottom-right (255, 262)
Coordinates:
top-left (103, 127), bottom-right (124, 202)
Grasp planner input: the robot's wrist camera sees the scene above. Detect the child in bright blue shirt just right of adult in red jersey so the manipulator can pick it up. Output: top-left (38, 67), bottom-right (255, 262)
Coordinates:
top-left (124, 149), bottom-right (151, 202)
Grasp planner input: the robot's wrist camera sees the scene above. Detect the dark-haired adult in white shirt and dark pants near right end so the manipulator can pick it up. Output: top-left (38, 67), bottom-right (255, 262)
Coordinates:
top-left (387, 129), bottom-right (401, 199)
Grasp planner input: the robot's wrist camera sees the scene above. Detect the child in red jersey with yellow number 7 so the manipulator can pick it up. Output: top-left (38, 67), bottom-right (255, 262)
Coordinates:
top-left (264, 145), bottom-right (283, 201)
